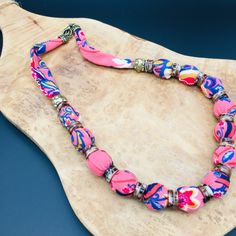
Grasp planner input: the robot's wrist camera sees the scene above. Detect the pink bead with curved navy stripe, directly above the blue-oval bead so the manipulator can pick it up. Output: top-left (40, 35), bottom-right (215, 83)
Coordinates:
top-left (214, 120), bottom-right (236, 142)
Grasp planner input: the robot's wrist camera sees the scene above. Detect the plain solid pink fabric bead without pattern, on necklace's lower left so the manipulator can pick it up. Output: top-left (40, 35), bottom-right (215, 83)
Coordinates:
top-left (86, 149), bottom-right (112, 176)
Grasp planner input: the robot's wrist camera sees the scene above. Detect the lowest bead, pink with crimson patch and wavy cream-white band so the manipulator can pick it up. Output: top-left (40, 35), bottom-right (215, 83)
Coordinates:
top-left (177, 186), bottom-right (205, 213)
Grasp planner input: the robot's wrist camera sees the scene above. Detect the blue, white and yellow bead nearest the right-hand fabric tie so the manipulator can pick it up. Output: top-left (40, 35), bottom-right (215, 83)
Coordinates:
top-left (153, 59), bottom-right (173, 79)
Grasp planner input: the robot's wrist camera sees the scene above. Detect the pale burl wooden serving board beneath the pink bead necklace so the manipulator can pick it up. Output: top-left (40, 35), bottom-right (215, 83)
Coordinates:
top-left (0, 1), bottom-right (236, 236)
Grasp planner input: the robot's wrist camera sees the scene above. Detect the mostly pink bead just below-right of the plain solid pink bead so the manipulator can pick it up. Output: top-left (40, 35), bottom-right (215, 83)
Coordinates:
top-left (110, 170), bottom-right (138, 196)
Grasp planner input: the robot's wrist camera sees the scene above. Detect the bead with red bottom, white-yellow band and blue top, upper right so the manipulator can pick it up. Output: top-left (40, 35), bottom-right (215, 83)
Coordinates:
top-left (179, 65), bottom-right (199, 85)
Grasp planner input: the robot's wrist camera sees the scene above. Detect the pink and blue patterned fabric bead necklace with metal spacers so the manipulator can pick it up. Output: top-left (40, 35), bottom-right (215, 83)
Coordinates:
top-left (30, 24), bottom-right (236, 213)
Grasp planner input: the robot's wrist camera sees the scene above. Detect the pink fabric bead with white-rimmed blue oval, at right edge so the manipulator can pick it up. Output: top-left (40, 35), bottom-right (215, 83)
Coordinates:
top-left (213, 146), bottom-right (236, 169)
